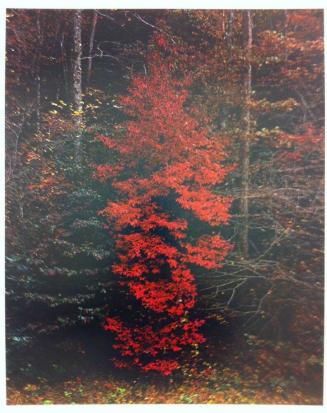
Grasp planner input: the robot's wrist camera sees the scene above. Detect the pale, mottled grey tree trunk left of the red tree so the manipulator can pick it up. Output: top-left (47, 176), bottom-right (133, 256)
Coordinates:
top-left (73, 10), bottom-right (83, 165)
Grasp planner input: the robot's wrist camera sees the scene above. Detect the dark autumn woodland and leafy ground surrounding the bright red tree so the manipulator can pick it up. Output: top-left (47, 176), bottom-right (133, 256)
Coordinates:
top-left (6, 9), bottom-right (324, 404)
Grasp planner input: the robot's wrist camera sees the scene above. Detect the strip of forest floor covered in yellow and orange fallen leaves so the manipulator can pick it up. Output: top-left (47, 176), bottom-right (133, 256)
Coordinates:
top-left (7, 358), bottom-right (322, 405)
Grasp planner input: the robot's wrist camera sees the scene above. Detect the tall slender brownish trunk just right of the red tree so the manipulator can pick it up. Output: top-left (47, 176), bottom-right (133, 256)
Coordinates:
top-left (240, 10), bottom-right (253, 259)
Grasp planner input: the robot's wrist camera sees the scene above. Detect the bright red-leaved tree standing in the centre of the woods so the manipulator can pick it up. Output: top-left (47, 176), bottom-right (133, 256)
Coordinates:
top-left (96, 38), bottom-right (231, 375)
